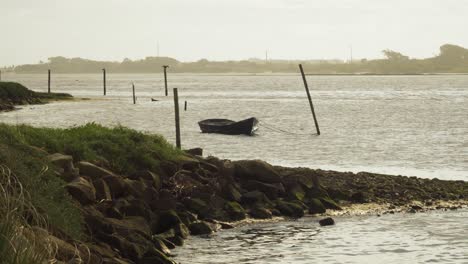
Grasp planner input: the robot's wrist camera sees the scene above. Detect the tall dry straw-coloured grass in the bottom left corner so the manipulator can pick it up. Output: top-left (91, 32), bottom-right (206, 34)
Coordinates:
top-left (0, 165), bottom-right (53, 264)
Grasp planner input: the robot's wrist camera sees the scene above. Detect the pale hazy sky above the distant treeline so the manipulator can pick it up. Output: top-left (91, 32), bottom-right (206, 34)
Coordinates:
top-left (0, 0), bottom-right (468, 65)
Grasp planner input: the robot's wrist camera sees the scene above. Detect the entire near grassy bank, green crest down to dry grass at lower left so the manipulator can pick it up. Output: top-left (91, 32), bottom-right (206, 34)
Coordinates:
top-left (0, 122), bottom-right (180, 263)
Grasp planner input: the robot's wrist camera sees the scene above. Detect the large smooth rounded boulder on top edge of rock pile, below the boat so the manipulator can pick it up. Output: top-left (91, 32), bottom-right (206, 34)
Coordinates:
top-left (233, 160), bottom-right (281, 183)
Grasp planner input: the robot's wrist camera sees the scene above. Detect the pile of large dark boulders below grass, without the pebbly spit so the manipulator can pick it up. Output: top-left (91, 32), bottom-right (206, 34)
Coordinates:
top-left (49, 153), bottom-right (340, 264)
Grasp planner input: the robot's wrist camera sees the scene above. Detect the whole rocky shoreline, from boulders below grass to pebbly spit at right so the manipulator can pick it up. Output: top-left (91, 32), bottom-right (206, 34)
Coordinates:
top-left (38, 150), bottom-right (468, 264)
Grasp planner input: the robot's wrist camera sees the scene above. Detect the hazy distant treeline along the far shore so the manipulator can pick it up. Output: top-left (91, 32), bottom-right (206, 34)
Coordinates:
top-left (10, 44), bottom-right (468, 74)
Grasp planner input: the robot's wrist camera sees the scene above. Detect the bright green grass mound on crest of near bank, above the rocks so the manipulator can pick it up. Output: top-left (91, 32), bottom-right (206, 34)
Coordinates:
top-left (0, 123), bottom-right (182, 174)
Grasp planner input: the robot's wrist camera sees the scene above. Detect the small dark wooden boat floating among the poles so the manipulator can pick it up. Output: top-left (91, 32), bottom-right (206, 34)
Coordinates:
top-left (198, 117), bottom-right (258, 136)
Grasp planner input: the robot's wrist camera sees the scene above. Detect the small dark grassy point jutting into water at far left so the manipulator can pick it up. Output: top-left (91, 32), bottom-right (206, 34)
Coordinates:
top-left (0, 82), bottom-right (72, 111)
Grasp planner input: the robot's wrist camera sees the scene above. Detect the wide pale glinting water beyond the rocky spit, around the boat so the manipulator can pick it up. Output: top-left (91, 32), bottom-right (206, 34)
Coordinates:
top-left (0, 73), bottom-right (468, 180)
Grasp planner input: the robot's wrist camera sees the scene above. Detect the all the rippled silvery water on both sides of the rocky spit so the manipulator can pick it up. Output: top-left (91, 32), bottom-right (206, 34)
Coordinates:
top-left (0, 74), bottom-right (468, 263)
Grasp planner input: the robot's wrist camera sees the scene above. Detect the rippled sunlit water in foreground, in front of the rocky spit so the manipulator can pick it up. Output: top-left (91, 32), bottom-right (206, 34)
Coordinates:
top-left (173, 209), bottom-right (468, 264)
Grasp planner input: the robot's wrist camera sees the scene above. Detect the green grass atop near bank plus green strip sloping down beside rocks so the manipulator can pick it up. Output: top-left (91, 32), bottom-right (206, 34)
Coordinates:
top-left (0, 123), bottom-right (182, 239)
